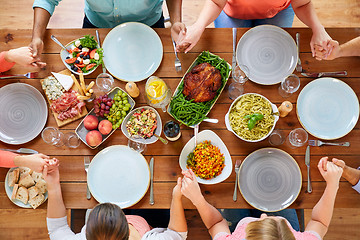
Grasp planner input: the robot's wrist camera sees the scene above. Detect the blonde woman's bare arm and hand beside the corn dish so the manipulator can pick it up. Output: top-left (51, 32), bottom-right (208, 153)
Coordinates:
top-left (181, 170), bottom-right (230, 238)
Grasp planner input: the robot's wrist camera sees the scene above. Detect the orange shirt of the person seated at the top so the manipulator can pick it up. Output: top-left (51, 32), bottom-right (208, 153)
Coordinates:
top-left (224, 0), bottom-right (291, 19)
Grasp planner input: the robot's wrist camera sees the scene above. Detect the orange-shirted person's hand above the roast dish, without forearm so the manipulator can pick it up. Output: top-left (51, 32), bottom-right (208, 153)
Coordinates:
top-left (176, 24), bottom-right (204, 53)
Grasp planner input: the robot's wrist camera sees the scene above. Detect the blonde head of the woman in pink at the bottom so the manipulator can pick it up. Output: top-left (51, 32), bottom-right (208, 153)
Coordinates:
top-left (245, 214), bottom-right (295, 240)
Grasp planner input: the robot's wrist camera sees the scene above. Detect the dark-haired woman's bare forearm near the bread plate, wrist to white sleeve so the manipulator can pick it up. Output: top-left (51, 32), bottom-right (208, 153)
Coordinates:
top-left (47, 183), bottom-right (66, 218)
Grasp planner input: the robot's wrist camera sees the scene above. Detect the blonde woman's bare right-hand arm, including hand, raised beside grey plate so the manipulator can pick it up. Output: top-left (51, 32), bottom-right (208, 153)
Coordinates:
top-left (305, 157), bottom-right (343, 238)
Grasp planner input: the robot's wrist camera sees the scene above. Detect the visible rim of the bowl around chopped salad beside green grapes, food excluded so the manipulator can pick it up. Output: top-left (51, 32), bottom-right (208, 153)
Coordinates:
top-left (121, 106), bottom-right (162, 144)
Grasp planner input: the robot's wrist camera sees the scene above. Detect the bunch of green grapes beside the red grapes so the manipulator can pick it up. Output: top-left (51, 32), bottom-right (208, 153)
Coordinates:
top-left (107, 90), bottom-right (131, 129)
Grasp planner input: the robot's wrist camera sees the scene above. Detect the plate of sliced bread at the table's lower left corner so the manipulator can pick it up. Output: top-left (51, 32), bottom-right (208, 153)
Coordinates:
top-left (5, 167), bottom-right (47, 209)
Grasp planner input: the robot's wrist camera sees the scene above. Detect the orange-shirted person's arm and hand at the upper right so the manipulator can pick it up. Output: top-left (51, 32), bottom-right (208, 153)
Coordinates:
top-left (291, 0), bottom-right (331, 57)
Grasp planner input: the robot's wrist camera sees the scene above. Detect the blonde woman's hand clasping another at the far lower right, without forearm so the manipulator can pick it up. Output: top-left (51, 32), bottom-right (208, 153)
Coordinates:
top-left (318, 157), bottom-right (343, 188)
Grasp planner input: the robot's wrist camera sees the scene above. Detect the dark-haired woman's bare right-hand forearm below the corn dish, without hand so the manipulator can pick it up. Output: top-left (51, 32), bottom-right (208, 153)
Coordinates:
top-left (168, 198), bottom-right (187, 232)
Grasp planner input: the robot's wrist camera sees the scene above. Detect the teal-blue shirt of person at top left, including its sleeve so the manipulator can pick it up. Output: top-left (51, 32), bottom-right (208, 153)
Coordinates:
top-left (33, 0), bottom-right (163, 28)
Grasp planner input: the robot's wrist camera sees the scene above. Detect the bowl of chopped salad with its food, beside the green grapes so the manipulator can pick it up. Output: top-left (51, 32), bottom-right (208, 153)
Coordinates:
top-left (121, 106), bottom-right (162, 144)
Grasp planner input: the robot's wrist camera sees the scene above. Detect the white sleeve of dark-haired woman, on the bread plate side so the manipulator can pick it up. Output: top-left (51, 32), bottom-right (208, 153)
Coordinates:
top-left (46, 216), bottom-right (86, 240)
